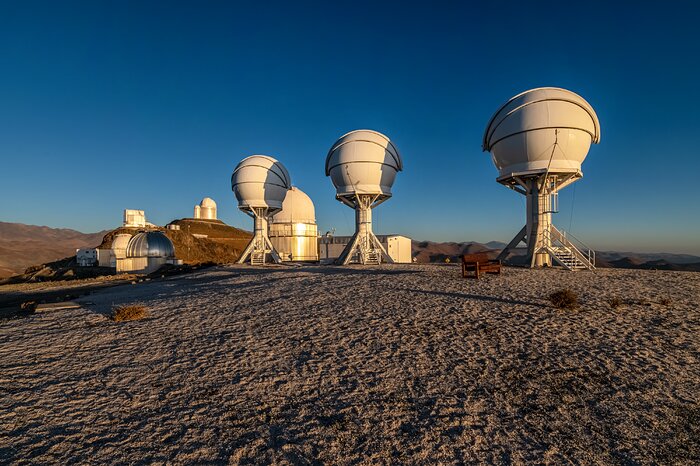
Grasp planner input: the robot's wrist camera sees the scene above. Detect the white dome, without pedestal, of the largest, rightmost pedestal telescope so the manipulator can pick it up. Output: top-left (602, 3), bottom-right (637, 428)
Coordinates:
top-left (482, 87), bottom-right (600, 177)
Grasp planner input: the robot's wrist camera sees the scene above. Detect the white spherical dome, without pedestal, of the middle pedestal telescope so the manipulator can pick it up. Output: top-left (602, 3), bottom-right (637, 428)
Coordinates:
top-left (326, 129), bottom-right (403, 198)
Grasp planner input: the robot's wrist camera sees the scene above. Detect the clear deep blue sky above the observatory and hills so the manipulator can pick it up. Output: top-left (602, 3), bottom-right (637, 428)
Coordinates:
top-left (0, 1), bottom-right (700, 254)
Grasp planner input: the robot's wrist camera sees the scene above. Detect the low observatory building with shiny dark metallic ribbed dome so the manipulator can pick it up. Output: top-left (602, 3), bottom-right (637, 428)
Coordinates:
top-left (115, 231), bottom-right (182, 273)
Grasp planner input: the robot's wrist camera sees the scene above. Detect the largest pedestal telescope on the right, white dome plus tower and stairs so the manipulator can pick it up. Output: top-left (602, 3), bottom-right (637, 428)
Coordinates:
top-left (483, 87), bottom-right (600, 270)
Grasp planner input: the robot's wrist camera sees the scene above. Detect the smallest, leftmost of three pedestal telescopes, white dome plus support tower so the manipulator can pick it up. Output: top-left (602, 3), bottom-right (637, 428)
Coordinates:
top-left (231, 155), bottom-right (292, 265)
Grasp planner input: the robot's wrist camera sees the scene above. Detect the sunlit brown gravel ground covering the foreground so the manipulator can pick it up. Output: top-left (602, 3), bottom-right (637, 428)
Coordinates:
top-left (0, 265), bottom-right (700, 464)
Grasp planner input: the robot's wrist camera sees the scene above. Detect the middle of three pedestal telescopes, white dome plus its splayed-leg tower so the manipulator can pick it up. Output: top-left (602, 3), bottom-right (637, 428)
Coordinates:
top-left (326, 129), bottom-right (403, 265)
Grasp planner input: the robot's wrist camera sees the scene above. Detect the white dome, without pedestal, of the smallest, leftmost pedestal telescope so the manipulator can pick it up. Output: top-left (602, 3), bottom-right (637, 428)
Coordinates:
top-left (231, 155), bottom-right (292, 211)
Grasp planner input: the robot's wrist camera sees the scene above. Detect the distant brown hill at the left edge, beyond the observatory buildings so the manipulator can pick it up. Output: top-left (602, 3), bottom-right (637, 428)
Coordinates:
top-left (0, 222), bottom-right (107, 278)
